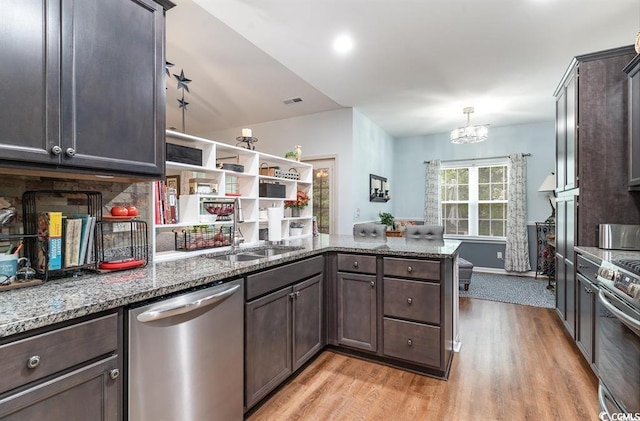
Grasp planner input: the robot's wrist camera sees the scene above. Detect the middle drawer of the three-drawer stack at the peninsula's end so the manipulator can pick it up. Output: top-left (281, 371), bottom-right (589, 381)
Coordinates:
top-left (384, 278), bottom-right (440, 324)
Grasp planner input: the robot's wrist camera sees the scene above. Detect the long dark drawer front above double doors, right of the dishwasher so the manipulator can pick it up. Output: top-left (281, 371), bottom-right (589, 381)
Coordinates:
top-left (246, 256), bottom-right (324, 300)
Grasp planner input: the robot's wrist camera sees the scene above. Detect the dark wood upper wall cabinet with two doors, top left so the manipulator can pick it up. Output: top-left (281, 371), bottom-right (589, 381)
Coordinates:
top-left (0, 0), bottom-right (170, 178)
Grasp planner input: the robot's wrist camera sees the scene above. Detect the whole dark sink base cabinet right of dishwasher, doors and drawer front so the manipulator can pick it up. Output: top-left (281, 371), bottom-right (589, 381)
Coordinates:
top-left (245, 256), bottom-right (324, 410)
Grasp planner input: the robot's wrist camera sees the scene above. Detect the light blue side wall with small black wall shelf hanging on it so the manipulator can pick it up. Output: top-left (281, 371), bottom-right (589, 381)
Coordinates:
top-left (352, 110), bottom-right (395, 222)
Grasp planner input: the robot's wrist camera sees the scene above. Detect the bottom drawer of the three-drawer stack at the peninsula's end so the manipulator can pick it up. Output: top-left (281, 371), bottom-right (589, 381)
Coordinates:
top-left (384, 317), bottom-right (441, 367)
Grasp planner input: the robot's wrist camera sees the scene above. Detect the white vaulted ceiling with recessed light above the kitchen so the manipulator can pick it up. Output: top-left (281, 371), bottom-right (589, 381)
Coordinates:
top-left (166, 0), bottom-right (640, 138)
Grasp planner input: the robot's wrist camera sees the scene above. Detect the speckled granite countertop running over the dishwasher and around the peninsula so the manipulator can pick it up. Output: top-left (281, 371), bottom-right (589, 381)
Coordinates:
top-left (0, 234), bottom-right (460, 337)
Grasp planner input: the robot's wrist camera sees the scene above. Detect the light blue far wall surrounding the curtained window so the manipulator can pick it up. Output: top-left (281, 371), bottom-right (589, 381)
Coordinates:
top-left (393, 121), bottom-right (556, 221)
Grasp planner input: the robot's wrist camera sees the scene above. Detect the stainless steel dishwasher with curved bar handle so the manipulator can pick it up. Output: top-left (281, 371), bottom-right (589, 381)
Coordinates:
top-left (128, 279), bottom-right (244, 421)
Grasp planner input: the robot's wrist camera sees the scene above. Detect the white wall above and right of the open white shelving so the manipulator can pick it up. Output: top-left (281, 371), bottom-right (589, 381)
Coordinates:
top-left (203, 108), bottom-right (356, 234)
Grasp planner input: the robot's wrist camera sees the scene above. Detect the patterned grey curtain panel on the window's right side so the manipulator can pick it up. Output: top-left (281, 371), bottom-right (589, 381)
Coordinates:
top-left (504, 153), bottom-right (531, 272)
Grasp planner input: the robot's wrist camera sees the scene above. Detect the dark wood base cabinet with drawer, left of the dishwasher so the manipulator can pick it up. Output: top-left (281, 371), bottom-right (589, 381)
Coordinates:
top-left (0, 312), bottom-right (123, 421)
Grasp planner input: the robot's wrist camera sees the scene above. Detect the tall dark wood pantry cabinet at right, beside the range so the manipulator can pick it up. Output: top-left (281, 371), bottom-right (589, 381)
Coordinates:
top-left (554, 46), bottom-right (640, 335)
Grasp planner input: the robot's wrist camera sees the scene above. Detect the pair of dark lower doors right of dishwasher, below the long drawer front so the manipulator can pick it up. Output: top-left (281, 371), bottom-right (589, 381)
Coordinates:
top-left (245, 274), bottom-right (323, 409)
